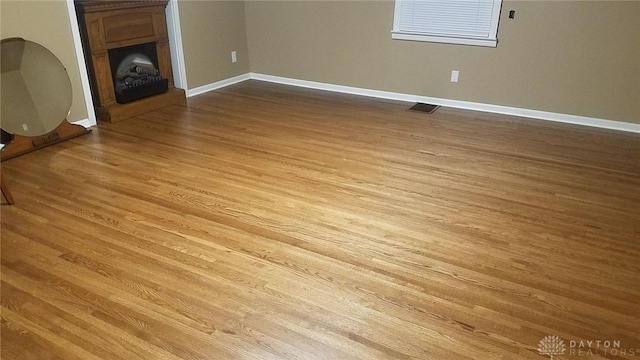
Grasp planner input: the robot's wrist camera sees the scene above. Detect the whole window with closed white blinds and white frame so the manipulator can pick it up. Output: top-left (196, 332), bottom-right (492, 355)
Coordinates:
top-left (391, 0), bottom-right (502, 47)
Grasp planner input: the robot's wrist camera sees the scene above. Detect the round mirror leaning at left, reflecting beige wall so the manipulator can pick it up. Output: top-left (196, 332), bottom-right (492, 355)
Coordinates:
top-left (0, 38), bottom-right (72, 137)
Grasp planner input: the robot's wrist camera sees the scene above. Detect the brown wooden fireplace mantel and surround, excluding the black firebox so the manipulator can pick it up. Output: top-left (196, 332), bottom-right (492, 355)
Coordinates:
top-left (76, 0), bottom-right (186, 122)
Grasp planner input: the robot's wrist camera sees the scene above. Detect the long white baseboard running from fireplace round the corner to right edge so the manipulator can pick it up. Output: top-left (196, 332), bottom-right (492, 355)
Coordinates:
top-left (187, 73), bottom-right (640, 133)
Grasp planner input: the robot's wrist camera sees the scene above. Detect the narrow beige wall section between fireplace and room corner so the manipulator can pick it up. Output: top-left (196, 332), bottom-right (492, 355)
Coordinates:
top-left (178, 0), bottom-right (249, 89)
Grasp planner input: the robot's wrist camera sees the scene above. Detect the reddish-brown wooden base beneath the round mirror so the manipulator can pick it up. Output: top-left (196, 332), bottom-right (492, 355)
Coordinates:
top-left (1, 120), bottom-right (90, 160)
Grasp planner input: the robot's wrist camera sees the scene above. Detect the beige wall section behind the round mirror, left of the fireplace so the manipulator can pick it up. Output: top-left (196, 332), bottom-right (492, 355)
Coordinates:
top-left (0, 0), bottom-right (88, 122)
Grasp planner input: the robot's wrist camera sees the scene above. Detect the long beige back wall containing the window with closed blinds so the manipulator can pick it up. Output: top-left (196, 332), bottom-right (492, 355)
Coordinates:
top-left (245, 0), bottom-right (640, 123)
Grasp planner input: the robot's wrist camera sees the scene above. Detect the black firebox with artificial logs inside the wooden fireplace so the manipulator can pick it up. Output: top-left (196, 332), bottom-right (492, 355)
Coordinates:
top-left (109, 42), bottom-right (169, 104)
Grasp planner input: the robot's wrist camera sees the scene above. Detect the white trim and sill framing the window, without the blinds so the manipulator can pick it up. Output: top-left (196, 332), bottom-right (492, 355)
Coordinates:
top-left (391, 0), bottom-right (502, 47)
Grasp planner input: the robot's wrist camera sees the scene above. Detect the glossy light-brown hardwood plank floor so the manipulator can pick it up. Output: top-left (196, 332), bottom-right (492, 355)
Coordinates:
top-left (1, 81), bottom-right (640, 360)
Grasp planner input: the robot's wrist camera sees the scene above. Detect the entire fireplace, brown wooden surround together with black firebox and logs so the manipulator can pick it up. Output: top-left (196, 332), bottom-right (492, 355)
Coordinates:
top-left (75, 0), bottom-right (186, 122)
